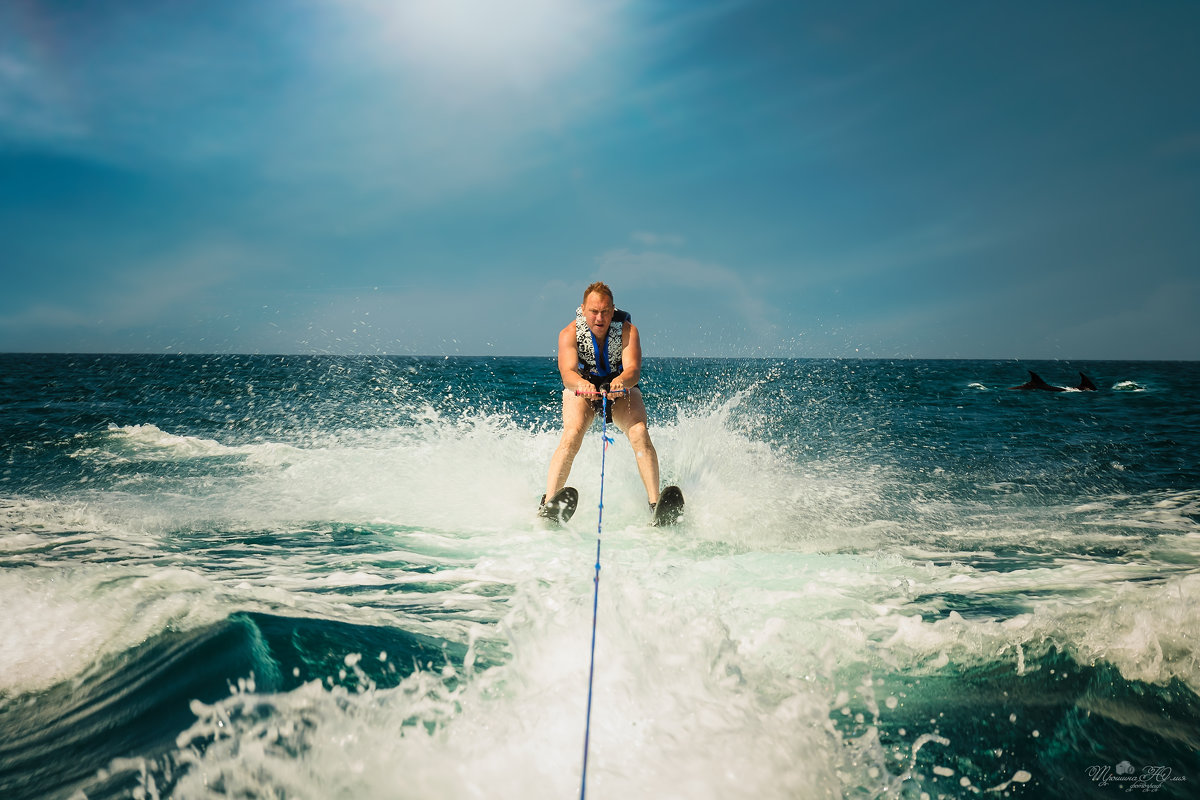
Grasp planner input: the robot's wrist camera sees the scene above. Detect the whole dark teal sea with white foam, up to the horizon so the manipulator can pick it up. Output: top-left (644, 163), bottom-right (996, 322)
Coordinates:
top-left (0, 354), bottom-right (1200, 800)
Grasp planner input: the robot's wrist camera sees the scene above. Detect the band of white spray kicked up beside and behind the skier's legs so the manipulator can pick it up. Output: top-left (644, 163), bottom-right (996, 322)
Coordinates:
top-left (32, 387), bottom-right (880, 554)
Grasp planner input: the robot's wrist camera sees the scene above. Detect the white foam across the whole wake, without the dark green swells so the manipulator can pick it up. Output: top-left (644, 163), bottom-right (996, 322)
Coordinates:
top-left (0, 396), bottom-right (1200, 799)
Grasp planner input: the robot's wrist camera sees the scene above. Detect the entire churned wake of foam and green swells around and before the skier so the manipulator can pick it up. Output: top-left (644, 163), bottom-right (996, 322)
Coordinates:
top-left (7, 373), bottom-right (1200, 799)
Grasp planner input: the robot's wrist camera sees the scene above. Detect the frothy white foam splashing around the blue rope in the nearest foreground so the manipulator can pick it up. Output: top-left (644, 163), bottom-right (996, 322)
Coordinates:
top-left (150, 548), bottom-right (840, 798)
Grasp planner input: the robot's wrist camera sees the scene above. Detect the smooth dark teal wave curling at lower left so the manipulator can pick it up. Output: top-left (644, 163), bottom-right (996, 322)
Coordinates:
top-left (0, 614), bottom-right (463, 800)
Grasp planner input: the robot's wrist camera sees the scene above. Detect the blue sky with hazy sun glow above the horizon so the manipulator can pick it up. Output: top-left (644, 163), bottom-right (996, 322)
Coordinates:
top-left (0, 0), bottom-right (1200, 360)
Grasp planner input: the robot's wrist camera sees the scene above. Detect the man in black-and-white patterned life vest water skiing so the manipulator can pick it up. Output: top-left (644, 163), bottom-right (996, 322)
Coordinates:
top-left (538, 281), bottom-right (662, 518)
